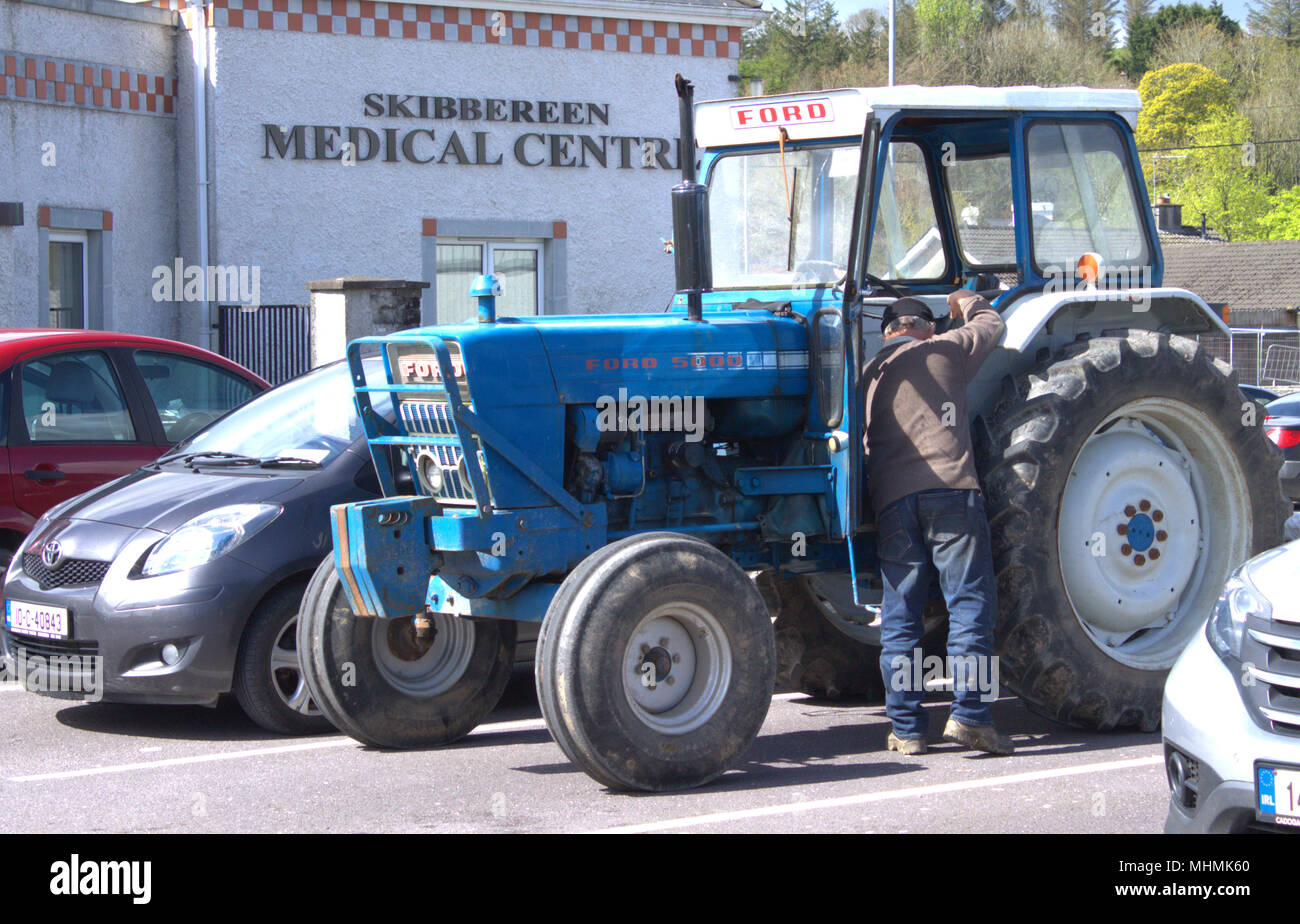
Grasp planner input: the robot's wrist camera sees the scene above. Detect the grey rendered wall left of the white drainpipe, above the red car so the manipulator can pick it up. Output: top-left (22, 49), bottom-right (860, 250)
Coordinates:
top-left (0, 0), bottom-right (178, 337)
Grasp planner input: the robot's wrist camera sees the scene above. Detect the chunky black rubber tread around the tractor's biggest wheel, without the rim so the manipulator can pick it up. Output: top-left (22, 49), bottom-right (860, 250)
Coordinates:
top-left (979, 330), bottom-right (1290, 730)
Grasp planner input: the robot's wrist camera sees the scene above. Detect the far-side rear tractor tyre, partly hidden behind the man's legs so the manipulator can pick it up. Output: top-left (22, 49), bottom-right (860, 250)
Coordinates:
top-left (758, 572), bottom-right (948, 700)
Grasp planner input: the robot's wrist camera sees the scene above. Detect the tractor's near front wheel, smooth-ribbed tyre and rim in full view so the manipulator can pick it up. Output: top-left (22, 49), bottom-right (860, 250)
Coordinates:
top-left (536, 533), bottom-right (776, 791)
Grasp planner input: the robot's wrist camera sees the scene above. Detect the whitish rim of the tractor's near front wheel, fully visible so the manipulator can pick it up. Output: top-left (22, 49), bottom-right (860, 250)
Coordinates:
top-left (623, 603), bottom-right (732, 734)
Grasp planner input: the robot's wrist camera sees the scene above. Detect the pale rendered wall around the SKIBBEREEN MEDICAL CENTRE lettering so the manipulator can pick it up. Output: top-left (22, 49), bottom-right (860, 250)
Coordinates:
top-left (197, 27), bottom-right (736, 318)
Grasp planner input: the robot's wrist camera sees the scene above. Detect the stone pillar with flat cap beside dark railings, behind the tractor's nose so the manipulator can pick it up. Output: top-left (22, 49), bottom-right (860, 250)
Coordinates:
top-left (307, 276), bottom-right (429, 369)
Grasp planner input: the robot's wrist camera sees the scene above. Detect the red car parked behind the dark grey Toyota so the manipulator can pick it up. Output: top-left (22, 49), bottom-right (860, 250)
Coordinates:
top-left (0, 329), bottom-right (270, 573)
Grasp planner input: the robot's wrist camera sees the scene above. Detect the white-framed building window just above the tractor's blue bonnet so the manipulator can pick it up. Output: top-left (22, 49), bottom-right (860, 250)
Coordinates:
top-left (437, 239), bottom-right (546, 324)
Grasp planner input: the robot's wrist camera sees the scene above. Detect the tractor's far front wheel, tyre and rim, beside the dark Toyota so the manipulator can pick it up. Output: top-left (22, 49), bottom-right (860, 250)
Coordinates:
top-left (298, 559), bottom-right (515, 749)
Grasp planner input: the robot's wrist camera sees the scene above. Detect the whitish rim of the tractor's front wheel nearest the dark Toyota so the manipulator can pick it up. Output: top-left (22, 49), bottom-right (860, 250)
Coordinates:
top-left (371, 613), bottom-right (475, 698)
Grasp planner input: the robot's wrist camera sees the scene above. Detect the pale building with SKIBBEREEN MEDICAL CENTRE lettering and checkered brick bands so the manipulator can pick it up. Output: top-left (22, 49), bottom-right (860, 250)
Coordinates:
top-left (0, 0), bottom-right (762, 376)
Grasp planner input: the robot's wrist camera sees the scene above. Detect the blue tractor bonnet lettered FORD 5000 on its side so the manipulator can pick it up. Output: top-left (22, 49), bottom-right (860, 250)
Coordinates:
top-left (378, 311), bottom-right (810, 509)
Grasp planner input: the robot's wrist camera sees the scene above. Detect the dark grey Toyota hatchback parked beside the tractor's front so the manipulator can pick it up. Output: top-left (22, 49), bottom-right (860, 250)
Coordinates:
top-left (0, 363), bottom-right (387, 733)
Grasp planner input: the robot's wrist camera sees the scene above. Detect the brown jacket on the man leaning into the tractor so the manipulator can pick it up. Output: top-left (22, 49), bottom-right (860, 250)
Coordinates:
top-left (863, 294), bottom-right (1006, 516)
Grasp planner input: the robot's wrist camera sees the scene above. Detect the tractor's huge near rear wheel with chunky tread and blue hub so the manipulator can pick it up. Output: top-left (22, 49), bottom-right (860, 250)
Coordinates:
top-left (982, 330), bottom-right (1288, 730)
